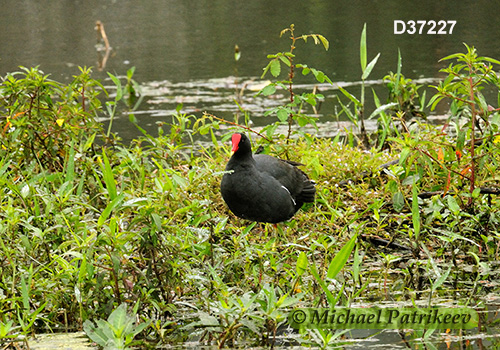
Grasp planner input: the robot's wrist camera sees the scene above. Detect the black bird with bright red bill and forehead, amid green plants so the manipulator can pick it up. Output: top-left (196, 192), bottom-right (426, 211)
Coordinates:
top-left (220, 133), bottom-right (316, 223)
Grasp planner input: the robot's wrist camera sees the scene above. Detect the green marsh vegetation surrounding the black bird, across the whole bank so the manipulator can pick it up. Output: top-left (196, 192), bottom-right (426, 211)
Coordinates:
top-left (0, 26), bottom-right (500, 348)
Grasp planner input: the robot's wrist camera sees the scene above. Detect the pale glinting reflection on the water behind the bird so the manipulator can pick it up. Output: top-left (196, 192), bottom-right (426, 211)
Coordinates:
top-left (125, 76), bottom-right (446, 137)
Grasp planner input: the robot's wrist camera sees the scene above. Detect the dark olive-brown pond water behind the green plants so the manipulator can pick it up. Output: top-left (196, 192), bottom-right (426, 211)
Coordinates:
top-left (0, 0), bottom-right (500, 141)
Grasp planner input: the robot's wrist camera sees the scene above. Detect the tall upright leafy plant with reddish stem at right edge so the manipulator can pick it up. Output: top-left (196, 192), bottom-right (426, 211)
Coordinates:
top-left (429, 45), bottom-right (500, 207)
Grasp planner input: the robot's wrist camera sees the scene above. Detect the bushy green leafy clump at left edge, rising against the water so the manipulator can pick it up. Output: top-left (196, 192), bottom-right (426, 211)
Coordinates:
top-left (0, 67), bottom-right (102, 171)
